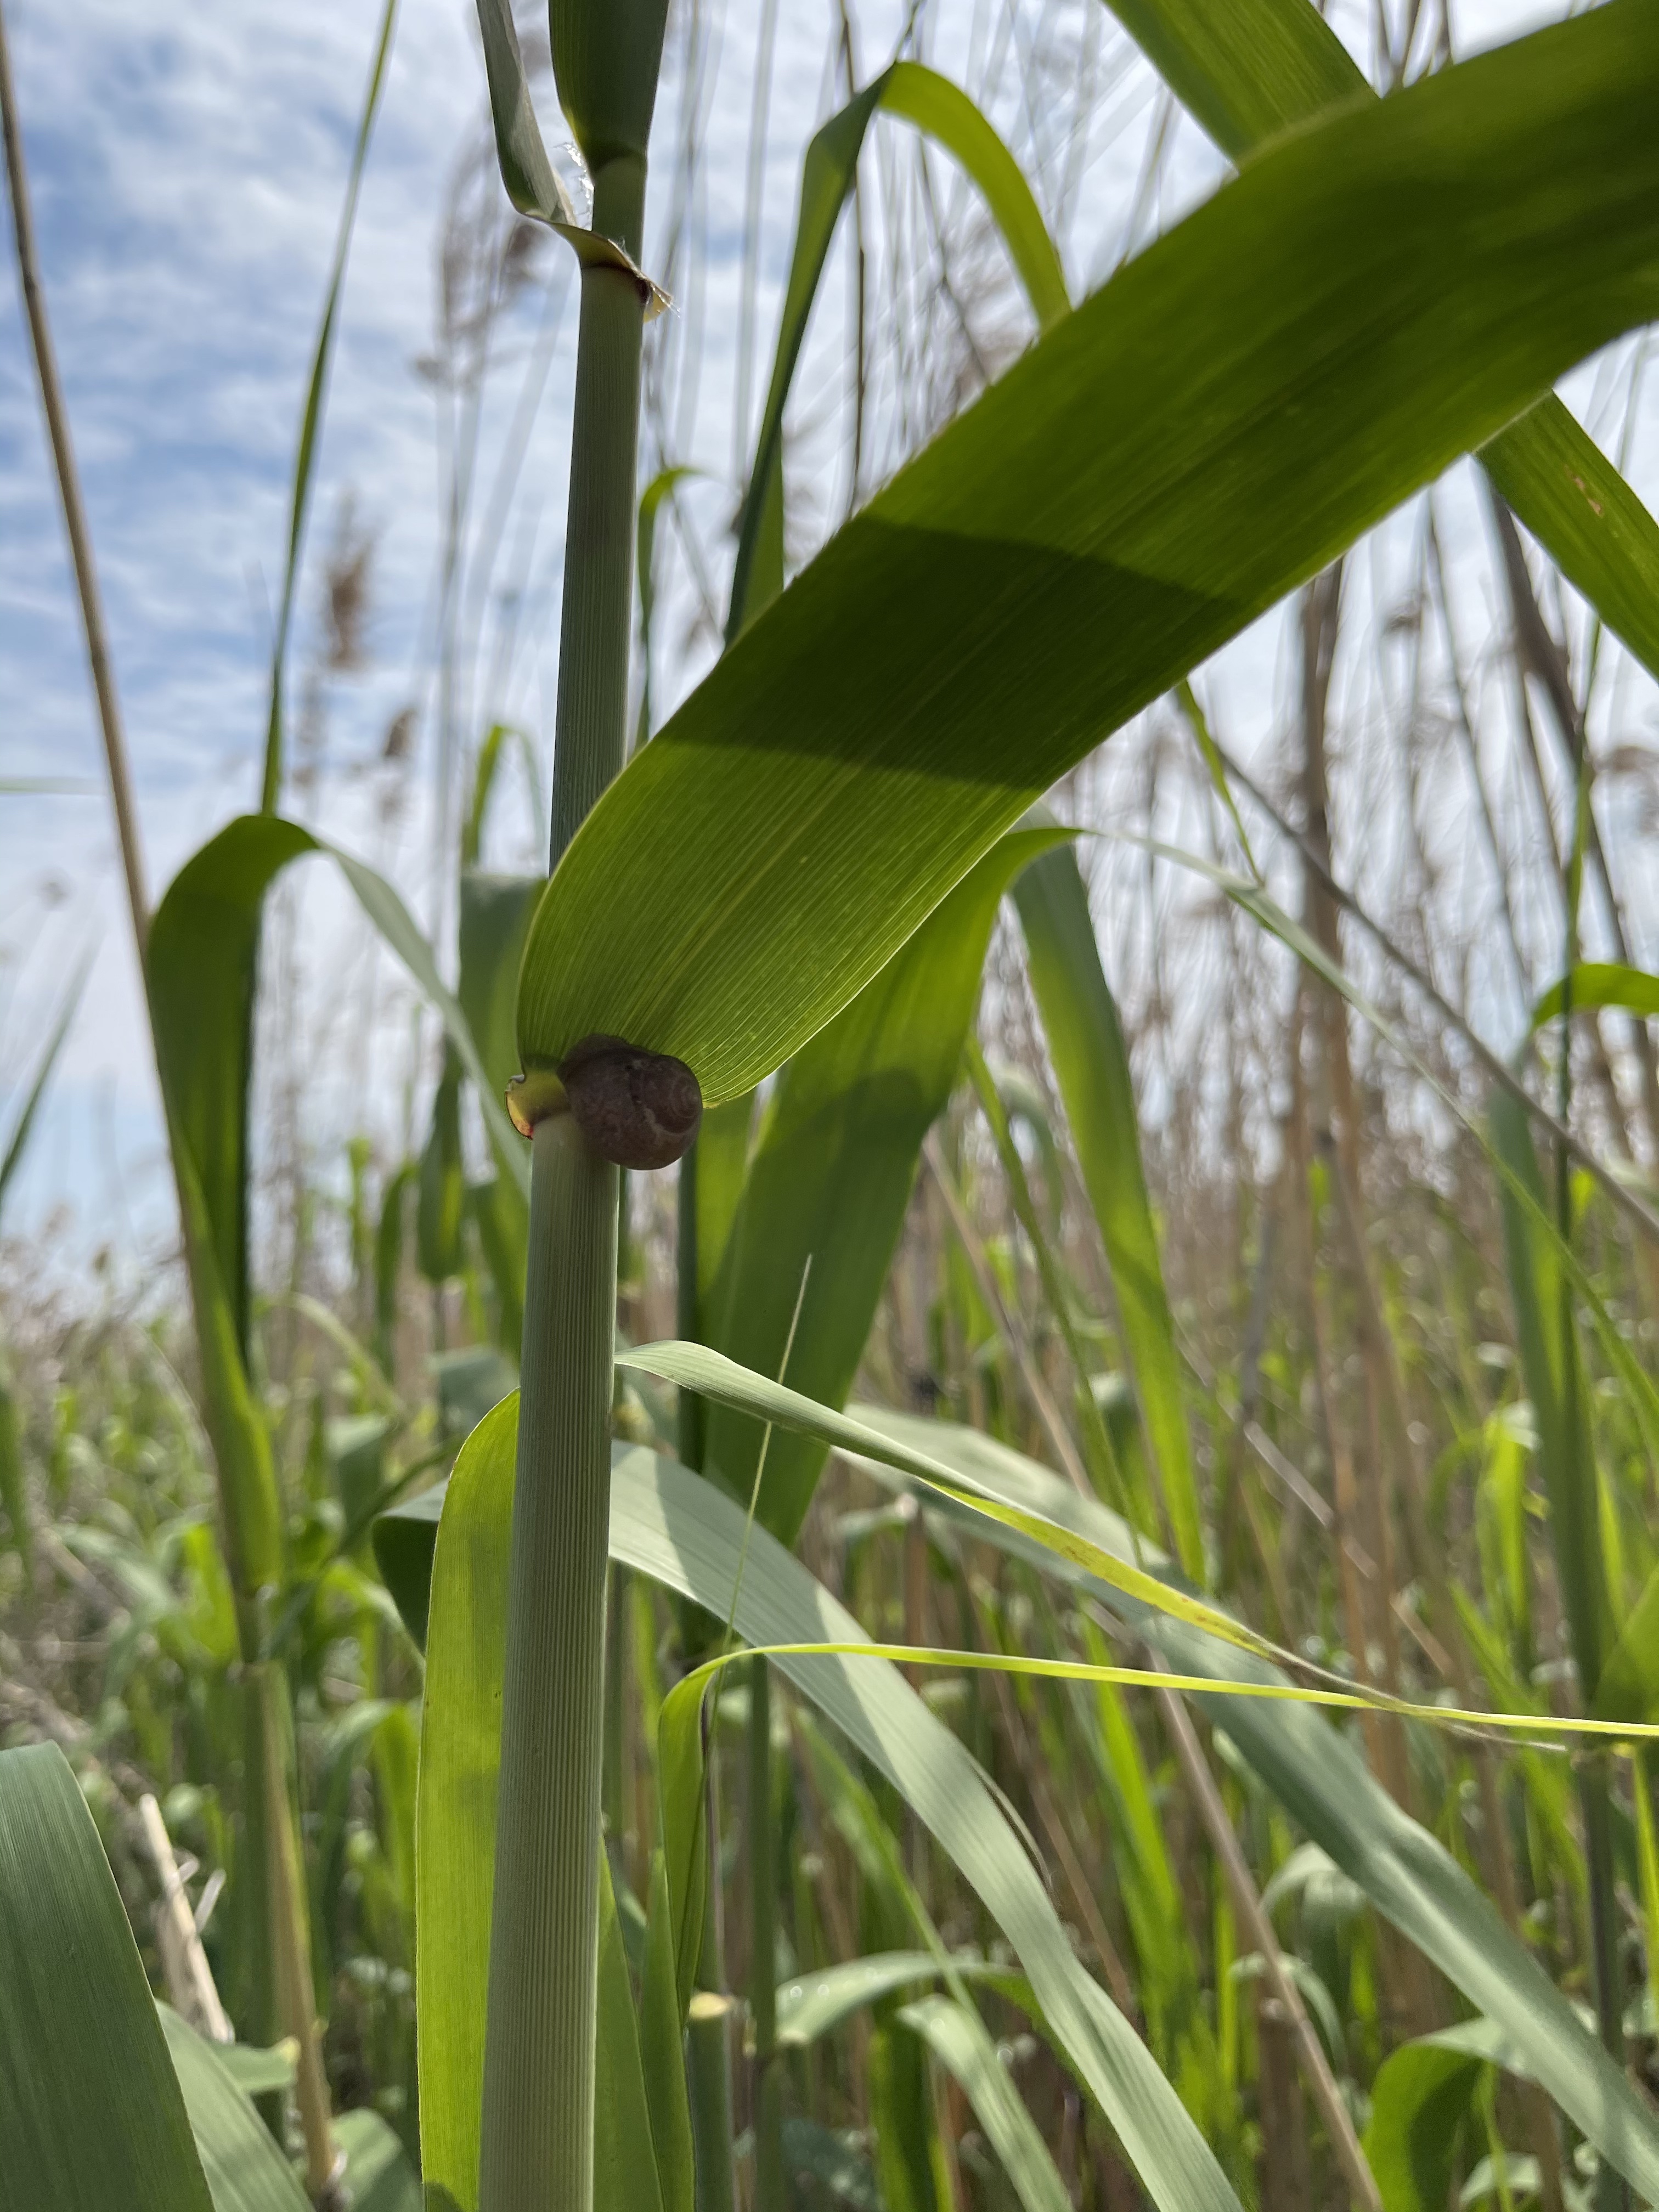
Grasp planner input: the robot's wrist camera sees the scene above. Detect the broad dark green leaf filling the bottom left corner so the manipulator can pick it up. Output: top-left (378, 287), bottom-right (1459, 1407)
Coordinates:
top-left (0, 1743), bottom-right (212, 2212)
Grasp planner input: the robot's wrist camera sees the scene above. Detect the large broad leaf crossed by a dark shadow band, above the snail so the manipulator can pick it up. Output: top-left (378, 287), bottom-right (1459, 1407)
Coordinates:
top-left (517, 0), bottom-right (1659, 1104)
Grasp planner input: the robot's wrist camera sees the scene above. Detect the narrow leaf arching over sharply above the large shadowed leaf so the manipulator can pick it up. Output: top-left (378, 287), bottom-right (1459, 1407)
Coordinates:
top-left (725, 62), bottom-right (1070, 641)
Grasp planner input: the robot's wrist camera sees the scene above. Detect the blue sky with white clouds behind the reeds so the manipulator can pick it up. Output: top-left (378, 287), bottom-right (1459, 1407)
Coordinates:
top-left (0, 0), bottom-right (1659, 1283)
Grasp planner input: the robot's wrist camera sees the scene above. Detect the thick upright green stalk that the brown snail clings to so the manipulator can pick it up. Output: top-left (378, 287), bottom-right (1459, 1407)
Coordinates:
top-left (480, 108), bottom-right (657, 2212)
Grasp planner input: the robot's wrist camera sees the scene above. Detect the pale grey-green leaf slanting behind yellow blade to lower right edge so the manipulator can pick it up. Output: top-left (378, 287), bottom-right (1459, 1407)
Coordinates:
top-left (845, 1407), bottom-right (1659, 2201)
